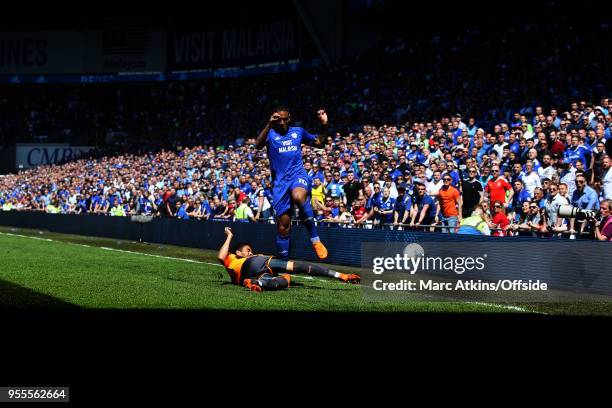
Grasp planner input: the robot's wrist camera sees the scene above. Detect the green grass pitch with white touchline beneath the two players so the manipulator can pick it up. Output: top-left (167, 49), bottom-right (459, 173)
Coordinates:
top-left (0, 227), bottom-right (612, 314)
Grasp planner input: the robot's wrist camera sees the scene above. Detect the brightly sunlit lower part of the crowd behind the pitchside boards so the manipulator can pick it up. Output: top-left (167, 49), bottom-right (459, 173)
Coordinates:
top-left (0, 98), bottom-right (612, 239)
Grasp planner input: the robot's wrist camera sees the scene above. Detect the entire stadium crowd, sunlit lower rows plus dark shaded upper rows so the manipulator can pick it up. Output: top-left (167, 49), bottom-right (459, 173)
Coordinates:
top-left (0, 23), bottom-right (612, 239)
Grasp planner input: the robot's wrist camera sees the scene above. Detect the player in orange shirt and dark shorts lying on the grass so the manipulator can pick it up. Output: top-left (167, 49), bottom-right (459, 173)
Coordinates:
top-left (217, 227), bottom-right (360, 292)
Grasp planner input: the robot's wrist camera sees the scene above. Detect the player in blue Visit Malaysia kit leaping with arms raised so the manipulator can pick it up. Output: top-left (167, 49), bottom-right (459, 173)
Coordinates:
top-left (255, 108), bottom-right (327, 260)
